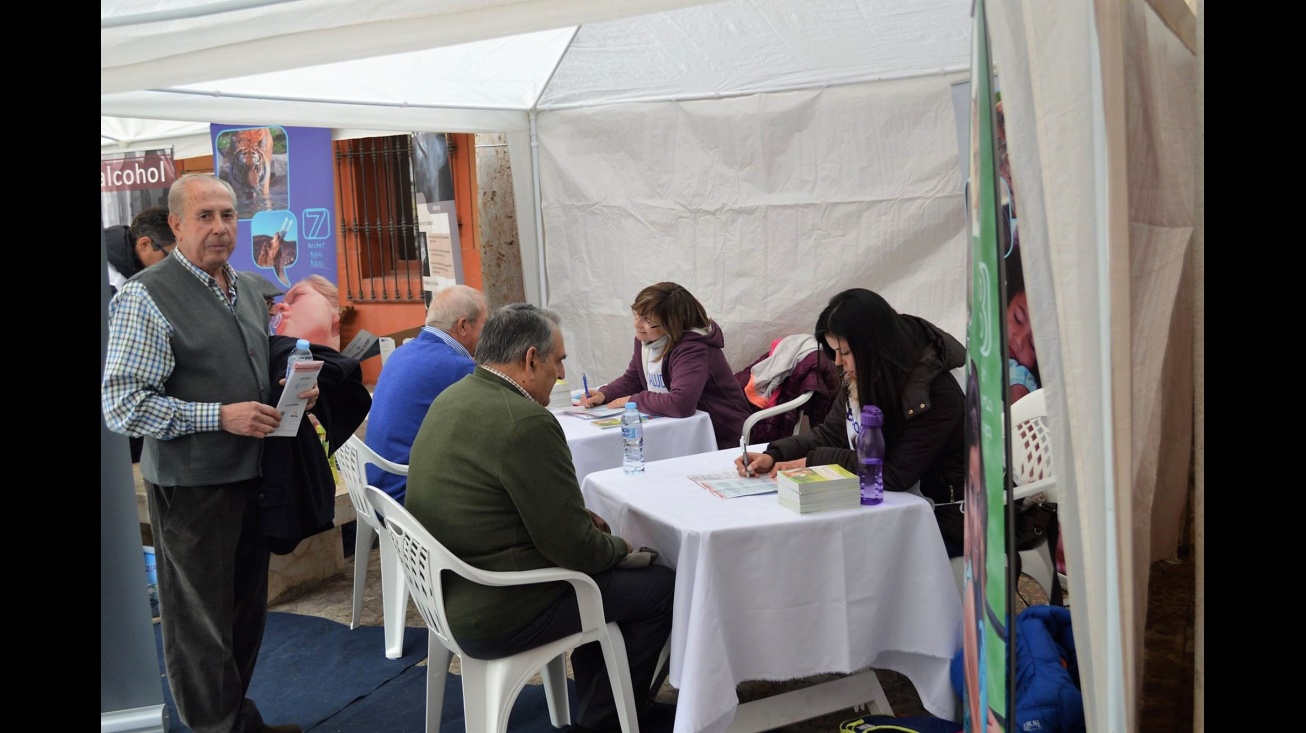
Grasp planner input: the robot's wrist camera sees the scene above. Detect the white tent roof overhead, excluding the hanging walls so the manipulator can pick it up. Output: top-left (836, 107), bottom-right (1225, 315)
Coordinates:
top-left (101, 0), bottom-right (970, 148)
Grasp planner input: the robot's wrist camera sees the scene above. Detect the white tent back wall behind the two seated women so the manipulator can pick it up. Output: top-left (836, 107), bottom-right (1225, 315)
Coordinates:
top-left (538, 74), bottom-right (966, 383)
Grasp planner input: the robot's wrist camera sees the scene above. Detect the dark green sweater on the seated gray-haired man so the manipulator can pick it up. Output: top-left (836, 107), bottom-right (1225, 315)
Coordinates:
top-left (405, 367), bottom-right (627, 639)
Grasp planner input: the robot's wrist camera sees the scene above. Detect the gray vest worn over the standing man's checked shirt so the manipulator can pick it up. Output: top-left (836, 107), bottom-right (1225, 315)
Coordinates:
top-left (132, 257), bottom-right (270, 486)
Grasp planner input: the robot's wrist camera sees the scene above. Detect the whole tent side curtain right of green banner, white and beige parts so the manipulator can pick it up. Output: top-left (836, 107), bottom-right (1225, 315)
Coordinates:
top-left (990, 0), bottom-right (1200, 730)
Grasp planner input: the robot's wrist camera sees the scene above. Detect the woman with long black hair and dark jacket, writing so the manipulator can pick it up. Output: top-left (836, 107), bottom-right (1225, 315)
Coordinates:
top-left (735, 287), bottom-right (965, 557)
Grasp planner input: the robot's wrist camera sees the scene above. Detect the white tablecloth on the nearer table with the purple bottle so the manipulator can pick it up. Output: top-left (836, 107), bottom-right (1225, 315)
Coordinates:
top-left (581, 449), bottom-right (961, 733)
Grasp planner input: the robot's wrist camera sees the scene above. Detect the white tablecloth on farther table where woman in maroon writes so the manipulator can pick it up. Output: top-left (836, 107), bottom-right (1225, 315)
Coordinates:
top-left (550, 408), bottom-right (717, 481)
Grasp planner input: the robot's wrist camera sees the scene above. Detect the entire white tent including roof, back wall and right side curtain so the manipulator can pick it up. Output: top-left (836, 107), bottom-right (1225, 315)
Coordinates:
top-left (101, 0), bottom-right (1200, 730)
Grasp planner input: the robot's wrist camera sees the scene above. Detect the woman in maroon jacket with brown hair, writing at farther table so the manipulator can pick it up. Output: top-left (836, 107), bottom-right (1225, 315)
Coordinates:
top-left (581, 282), bottom-right (752, 448)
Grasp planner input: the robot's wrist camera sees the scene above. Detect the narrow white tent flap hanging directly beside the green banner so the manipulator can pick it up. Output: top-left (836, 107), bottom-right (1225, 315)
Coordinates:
top-left (989, 0), bottom-right (1126, 730)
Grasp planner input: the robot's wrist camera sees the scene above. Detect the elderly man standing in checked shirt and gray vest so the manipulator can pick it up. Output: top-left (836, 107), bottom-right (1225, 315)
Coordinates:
top-left (101, 174), bottom-right (308, 733)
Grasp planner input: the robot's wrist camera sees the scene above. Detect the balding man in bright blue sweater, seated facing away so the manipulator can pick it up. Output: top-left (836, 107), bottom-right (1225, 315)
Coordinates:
top-left (366, 285), bottom-right (486, 504)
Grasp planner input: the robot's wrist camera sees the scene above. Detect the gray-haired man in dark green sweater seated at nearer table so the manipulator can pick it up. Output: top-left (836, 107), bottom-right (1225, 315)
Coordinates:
top-left (407, 303), bottom-right (675, 732)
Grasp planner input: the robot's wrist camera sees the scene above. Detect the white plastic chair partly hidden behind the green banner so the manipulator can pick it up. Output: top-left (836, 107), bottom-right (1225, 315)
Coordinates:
top-left (1011, 389), bottom-right (1064, 598)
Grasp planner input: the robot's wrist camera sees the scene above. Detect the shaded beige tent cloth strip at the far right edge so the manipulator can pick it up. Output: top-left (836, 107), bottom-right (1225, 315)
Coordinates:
top-left (1126, 0), bottom-right (1198, 567)
